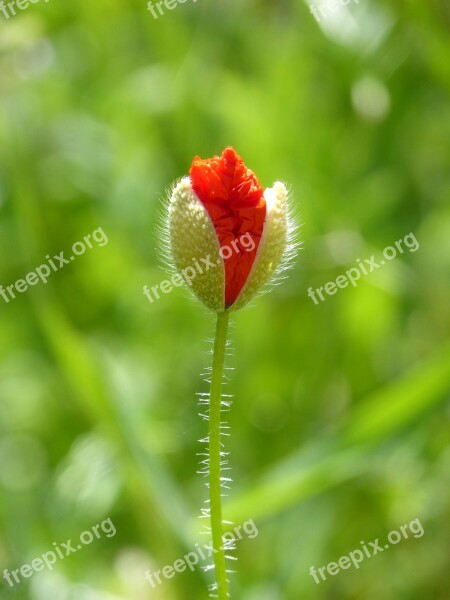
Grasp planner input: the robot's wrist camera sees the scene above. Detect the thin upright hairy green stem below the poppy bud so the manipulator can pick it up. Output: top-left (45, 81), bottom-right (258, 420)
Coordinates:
top-left (209, 311), bottom-right (229, 600)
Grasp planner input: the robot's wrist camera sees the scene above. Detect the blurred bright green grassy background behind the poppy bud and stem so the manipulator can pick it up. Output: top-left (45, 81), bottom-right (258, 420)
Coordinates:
top-left (0, 0), bottom-right (450, 600)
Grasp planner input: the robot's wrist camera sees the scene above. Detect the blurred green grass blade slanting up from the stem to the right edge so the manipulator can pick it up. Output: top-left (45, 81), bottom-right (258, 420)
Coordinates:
top-left (224, 346), bottom-right (450, 523)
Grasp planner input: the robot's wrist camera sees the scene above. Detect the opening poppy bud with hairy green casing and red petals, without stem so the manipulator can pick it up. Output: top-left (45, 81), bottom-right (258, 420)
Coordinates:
top-left (166, 147), bottom-right (293, 312)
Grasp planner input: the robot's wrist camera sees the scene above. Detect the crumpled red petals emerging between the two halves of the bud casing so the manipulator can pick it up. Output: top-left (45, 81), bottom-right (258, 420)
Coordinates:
top-left (189, 147), bottom-right (266, 308)
